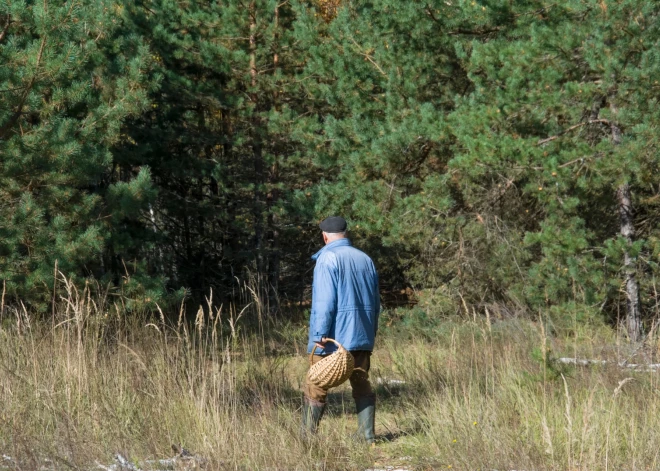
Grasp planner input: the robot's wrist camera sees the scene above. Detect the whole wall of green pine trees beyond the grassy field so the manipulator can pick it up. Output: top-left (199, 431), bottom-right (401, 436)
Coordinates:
top-left (0, 0), bottom-right (660, 338)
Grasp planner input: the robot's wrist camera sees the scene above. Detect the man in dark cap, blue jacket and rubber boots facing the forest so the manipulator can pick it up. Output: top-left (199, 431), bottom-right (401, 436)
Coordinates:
top-left (302, 217), bottom-right (380, 443)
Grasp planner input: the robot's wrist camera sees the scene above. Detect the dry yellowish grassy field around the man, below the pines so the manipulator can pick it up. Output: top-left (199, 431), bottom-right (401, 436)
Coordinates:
top-left (0, 290), bottom-right (660, 470)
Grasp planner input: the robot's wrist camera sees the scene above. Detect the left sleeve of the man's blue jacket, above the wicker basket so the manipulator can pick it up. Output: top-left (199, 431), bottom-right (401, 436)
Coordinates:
top-left (310, 257), bottom-right (338, 342)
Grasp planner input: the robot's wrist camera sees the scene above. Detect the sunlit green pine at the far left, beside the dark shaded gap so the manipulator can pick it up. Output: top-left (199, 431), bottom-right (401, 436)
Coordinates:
top-left (0, 0), bottom-right (151, 307)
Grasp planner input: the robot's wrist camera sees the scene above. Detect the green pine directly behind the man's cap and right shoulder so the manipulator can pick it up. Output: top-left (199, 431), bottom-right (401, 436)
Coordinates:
top-left (288, 0), bottom-right (480, 298)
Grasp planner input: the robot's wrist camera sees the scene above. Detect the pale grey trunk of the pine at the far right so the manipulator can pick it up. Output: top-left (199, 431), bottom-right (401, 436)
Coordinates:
top-left (610, 100), bottom-right (642, 342)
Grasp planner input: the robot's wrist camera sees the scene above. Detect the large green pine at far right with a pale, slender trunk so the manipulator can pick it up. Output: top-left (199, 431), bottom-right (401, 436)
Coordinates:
top-left (451, 1), bottom-right (660, 340)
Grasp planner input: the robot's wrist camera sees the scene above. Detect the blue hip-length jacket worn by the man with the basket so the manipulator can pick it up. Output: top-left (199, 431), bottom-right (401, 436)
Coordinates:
top-left (307, 239), bottom-right (380, 354)
